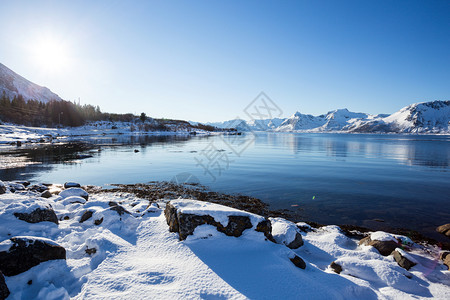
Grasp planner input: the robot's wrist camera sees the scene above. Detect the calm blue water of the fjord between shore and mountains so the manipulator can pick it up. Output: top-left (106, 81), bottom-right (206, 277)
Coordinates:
top-left (0, 133), bottom-right (450, 237)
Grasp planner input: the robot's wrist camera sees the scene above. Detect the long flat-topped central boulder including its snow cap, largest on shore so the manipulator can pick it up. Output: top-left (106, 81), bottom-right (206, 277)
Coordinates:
top-left (164, 200), bottom-right (273, 240)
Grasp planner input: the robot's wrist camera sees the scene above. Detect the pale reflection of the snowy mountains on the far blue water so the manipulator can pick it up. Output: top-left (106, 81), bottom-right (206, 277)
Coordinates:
top-left (256, 133), bottom-right (450, 169)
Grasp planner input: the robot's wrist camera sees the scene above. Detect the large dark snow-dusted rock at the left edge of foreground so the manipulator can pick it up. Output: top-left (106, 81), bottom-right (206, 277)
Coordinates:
top-left (0, 236), bottom-right (66, 276)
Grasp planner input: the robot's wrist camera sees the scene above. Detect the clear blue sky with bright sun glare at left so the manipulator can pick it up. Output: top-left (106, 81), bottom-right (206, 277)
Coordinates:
top-left (0, 0), bottom-right (450, 122)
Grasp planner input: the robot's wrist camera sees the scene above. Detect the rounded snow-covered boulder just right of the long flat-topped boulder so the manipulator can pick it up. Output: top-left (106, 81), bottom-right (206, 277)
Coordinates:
top-left (269, 218), bottom-right (303, 249)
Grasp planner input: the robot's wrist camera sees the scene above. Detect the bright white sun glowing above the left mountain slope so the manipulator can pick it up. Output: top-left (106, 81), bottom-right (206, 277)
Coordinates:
top-left (32, 37), bottom-right (69, 72)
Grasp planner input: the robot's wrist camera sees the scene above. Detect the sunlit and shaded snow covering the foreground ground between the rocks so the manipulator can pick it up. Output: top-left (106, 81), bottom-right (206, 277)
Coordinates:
top-left (0, 182), bottom-right (450, 299)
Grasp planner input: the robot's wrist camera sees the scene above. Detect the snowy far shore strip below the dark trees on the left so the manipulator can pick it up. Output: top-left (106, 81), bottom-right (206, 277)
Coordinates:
top-left (0, 121), bottom-right (214, 144)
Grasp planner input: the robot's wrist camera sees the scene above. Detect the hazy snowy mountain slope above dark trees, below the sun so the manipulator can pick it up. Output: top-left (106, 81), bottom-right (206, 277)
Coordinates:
top-left (0, 63), bottom-right (62, 102)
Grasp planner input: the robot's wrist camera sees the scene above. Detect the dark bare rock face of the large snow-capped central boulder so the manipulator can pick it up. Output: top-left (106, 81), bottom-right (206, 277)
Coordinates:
top-left (164, 203), bottom-right (264, 240)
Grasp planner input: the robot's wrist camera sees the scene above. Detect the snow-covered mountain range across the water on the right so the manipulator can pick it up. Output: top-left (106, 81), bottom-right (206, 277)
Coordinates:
top-left (209, 101), bottom-right (450, 134)
